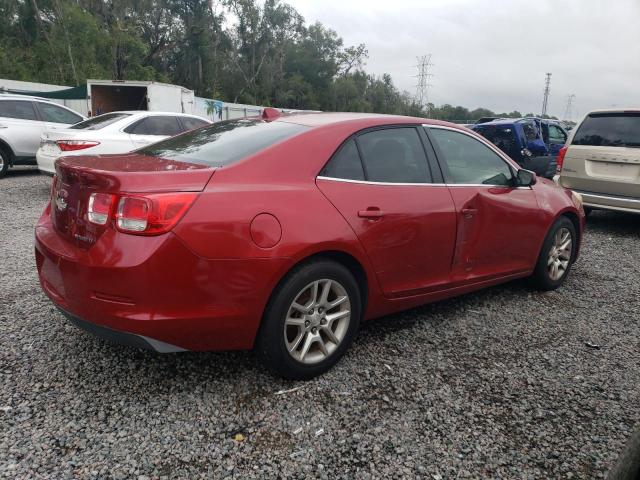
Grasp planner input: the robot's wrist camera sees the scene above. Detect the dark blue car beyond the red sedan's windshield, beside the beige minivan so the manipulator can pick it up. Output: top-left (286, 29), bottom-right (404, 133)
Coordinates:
top-left (472, 118), bottom-right (567, 178)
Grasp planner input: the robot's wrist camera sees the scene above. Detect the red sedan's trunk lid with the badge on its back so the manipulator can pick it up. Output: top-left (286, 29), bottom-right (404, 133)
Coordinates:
top-left (51, 153), bottom-right (215, 249)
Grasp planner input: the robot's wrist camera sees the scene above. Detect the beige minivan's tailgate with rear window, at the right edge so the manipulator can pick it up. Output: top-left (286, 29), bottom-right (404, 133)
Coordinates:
top-left (560, 112), bottom-right (640, 198)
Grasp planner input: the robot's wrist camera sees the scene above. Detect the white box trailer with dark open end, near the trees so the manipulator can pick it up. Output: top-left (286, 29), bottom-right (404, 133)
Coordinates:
top-left (87, 80), bottom-right (195, 116)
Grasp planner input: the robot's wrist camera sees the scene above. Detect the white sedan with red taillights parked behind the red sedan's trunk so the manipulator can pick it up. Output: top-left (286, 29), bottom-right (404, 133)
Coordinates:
top-left (36, 111), bottom-right (211, 175)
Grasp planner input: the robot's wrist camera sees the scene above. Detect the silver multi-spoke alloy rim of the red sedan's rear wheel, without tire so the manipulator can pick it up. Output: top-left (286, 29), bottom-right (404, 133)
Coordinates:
top-left (284, 278), bottom-right (351, 364)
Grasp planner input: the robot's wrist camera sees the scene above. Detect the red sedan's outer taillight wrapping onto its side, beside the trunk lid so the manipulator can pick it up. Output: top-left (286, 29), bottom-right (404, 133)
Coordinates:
top-left (116, 192), bottom-right (198, 235)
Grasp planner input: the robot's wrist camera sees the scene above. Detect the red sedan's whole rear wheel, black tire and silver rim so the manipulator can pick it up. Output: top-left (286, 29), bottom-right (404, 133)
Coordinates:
top-left (256, 260), bottom-right (362, 380)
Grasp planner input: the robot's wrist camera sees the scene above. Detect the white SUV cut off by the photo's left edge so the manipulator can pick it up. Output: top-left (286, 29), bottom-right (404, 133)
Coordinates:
top-left (0, 94), bottom-right (84, 178)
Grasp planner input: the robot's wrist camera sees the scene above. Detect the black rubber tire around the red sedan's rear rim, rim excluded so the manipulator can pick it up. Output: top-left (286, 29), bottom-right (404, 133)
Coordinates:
top-left (256, 260), bottom-right (362, 380)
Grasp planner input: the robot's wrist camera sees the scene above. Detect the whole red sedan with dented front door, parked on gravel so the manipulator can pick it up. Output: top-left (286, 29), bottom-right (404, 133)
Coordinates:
top-left (36, 111), bottom-right (584, 379)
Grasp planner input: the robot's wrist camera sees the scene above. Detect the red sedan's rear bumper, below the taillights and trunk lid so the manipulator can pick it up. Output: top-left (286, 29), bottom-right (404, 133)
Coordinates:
top-left (35, 207), bottom-right (288, 352)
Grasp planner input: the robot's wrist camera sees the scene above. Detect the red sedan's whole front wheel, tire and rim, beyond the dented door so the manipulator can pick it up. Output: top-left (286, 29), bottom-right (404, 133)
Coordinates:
top-left (531, 216), bottom-right (578, 290)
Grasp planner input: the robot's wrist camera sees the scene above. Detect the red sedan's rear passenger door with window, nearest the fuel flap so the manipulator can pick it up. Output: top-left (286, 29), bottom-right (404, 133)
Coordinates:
top-left (317, 126), bottom-right (456, 297)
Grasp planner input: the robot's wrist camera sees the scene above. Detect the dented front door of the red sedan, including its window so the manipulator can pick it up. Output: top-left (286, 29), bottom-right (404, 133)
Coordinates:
top-left (427, 126), bottom-right (544, 284)
